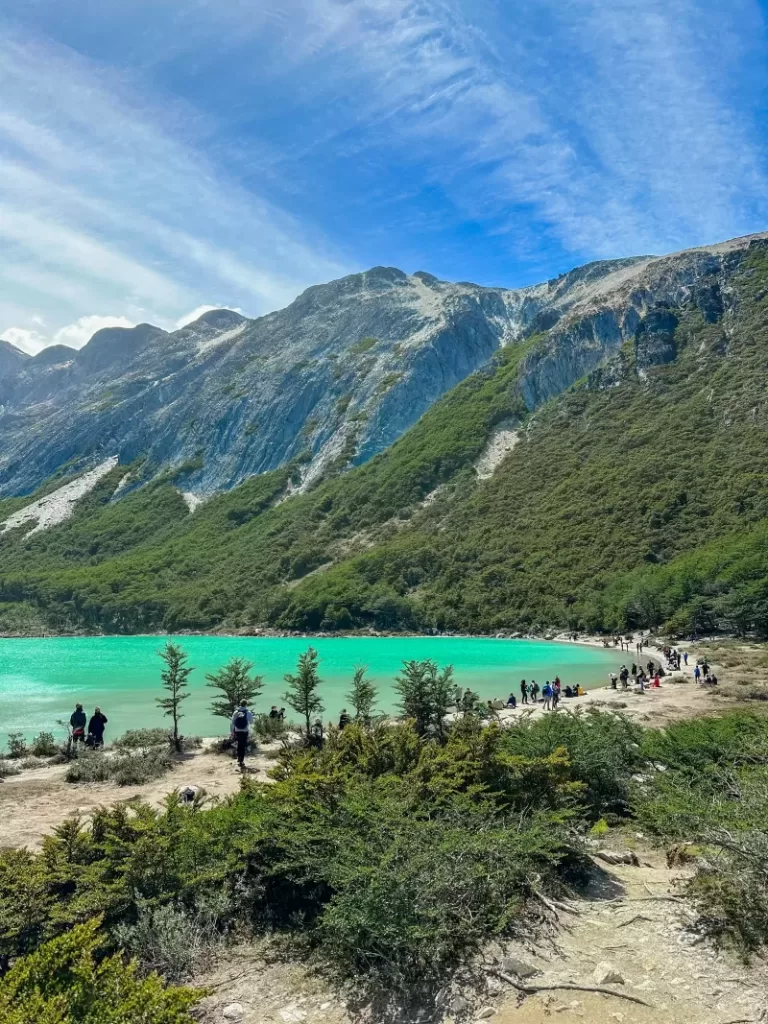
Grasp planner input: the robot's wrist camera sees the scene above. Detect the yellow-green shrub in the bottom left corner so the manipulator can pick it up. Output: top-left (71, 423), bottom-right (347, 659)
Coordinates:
top-left (0, 920), bottom-right (205, 1024)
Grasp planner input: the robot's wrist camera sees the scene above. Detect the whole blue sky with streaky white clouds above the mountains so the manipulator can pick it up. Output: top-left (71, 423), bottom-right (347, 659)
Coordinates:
top-left (0, 0), bottom-right (768, 351)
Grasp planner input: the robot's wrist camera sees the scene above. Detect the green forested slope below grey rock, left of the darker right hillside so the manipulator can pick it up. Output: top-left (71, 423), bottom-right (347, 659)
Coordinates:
top-left (0, 339), bottom-right (537, 632)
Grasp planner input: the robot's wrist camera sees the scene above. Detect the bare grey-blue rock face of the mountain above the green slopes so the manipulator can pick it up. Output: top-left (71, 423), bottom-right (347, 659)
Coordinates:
top-left (0, 240), bottom-right (765, 497)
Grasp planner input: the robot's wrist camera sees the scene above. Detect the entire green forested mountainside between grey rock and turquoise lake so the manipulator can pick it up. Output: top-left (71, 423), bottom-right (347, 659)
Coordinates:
top-left (0, 241), bottom-right (768, 632)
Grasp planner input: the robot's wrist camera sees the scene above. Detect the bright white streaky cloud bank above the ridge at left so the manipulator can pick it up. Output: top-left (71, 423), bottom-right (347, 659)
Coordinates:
top-left (0, 28), bottom-right (344, 345)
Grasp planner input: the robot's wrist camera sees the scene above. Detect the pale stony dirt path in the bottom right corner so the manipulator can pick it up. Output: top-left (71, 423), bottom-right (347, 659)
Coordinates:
top-left (495, 847), bottom-right (768, 1024)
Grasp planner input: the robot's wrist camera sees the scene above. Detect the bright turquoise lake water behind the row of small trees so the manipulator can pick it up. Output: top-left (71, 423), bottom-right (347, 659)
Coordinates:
top-left (0, 636), bottom-right (628, 746)
